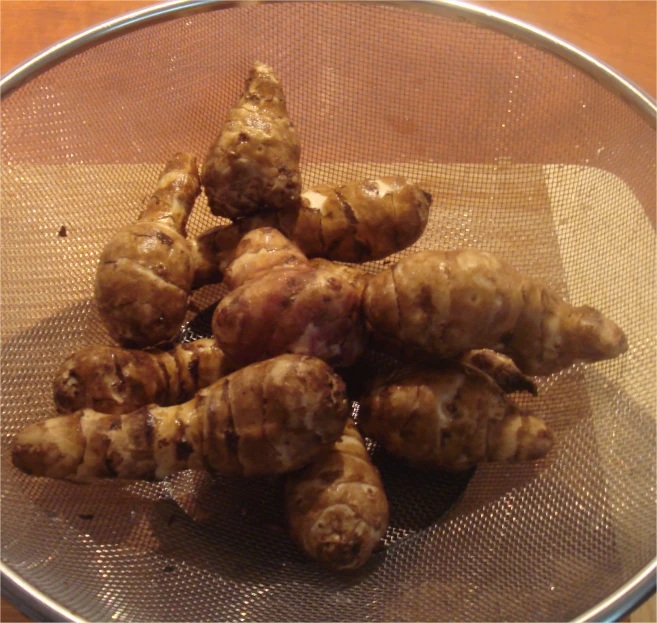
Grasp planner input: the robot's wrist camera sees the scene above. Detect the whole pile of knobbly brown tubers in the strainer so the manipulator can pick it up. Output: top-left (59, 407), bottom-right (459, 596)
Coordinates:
top-left (12, 63), bottom-right (627, 571)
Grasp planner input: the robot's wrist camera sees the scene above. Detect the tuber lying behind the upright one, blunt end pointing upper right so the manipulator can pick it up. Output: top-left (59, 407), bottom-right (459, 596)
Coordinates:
top-left (193, 177), bottom-right (431, 288)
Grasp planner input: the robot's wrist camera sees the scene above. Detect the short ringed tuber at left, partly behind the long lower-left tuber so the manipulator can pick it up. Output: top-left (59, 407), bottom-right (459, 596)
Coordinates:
top-left (54, 339), bottom-right (235, 414)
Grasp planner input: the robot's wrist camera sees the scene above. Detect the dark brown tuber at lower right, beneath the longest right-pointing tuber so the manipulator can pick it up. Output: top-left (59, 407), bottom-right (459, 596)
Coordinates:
top-left (358, 361), bottom-right (553, 470)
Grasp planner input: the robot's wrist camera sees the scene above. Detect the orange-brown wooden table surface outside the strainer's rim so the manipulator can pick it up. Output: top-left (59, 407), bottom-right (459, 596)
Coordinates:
top-left (0, 0), bottom-right (657, 622)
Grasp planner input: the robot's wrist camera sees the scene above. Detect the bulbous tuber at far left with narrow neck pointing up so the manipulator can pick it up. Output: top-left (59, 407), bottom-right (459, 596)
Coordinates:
top-left (95, 153), bottom-right (200, 348)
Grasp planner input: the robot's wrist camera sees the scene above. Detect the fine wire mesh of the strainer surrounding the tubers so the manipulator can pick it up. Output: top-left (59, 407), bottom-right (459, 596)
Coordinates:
top-left (1, 2), bottom-right (657, 621)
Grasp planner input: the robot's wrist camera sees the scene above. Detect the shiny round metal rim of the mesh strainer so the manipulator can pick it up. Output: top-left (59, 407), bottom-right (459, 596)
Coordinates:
top-left (0, 0), bottom-right (657, 622)
